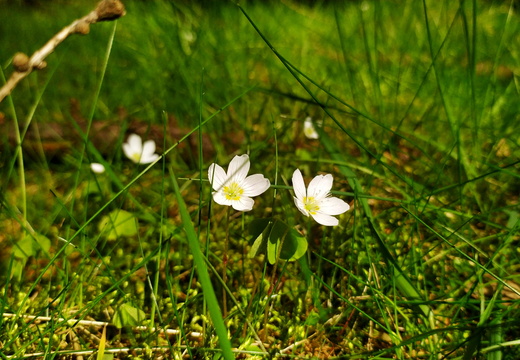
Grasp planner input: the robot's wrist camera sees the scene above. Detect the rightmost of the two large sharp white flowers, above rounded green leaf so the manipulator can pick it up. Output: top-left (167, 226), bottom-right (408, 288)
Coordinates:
top-left (292, 169), bottom-right (350, 226)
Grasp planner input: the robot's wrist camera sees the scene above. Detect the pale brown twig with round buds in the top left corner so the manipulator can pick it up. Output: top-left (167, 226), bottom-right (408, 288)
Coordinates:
top-left (0, 0), bottom-right (125, 102)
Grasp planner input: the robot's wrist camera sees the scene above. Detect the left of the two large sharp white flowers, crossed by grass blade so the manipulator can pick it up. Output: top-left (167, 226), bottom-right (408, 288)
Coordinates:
top-left (208, 155), bottom-right (271, 211)
